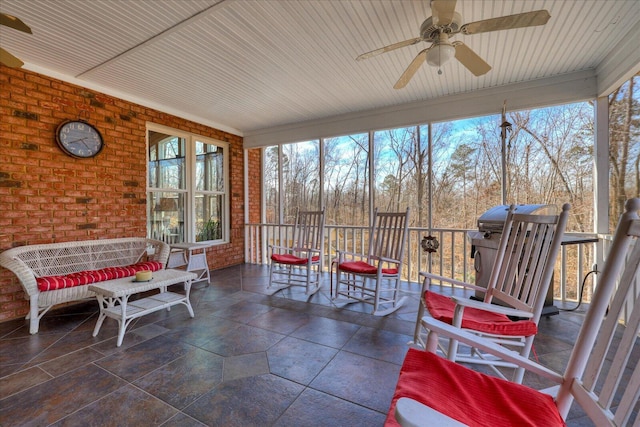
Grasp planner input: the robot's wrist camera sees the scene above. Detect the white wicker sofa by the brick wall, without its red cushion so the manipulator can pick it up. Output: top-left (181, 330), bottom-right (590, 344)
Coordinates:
top-left (0, 237), bottom-right (170, 334)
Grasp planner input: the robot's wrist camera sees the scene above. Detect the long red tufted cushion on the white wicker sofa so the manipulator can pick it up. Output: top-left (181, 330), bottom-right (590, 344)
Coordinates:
top-left (36, 261), bottom-right (162, 292)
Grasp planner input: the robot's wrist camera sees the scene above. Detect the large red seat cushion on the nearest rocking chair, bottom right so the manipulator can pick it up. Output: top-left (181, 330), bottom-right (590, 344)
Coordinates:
top-left (385, 348), bottom-right (566, 427)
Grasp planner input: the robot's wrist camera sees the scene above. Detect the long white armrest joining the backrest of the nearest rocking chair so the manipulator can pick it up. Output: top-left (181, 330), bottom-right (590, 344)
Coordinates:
top-left (422, 316), bottom-right (563, 384)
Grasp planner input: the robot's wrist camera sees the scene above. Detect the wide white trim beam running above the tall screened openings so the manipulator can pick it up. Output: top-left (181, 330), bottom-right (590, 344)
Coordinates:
top-left (244, 70), bottom-right (597, 148)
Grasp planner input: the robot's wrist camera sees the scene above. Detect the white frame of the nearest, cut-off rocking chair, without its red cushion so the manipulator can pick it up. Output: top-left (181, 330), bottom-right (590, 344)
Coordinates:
top-left (395, 198), bottom-right (640, 427)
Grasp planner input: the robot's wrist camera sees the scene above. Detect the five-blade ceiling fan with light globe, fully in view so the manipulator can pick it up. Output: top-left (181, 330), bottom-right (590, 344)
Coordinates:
top-left (356, 0), bottom-right (551, 89)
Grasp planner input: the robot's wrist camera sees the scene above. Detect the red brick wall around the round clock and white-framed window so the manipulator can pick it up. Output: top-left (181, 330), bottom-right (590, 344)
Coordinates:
top-left (0, 65), bottom-right (246, 321)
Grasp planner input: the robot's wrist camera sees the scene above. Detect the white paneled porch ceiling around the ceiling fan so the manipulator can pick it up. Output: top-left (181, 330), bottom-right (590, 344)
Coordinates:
top-left (0, 0), bottom-right (640, 145)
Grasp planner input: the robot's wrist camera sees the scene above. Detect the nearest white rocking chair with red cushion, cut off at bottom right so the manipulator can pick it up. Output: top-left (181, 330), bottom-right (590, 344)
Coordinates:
top-left (386, 199), bottom-right (640, 427)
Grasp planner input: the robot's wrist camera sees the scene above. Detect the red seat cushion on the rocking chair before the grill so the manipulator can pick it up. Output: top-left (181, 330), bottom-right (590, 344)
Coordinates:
top-left (424, 291), bottom-right (538, 337)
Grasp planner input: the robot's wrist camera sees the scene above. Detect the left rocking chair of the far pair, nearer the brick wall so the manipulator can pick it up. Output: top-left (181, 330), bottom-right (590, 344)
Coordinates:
top-left (268, 209), bottom-right (324, 297)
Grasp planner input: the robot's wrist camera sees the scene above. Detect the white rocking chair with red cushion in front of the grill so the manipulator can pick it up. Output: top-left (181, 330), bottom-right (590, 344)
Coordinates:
top-left (414, 204), bottom-right (570, 383)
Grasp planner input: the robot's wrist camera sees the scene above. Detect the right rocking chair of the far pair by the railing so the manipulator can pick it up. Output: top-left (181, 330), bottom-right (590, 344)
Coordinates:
top-left (334, 209), bottom-right (409, 316)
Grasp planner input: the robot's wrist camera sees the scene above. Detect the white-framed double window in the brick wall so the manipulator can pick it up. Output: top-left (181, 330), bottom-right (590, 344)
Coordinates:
top-left (147, 124), bottom-right (229, 243)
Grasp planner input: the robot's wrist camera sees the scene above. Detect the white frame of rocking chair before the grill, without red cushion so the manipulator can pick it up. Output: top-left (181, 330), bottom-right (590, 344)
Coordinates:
top-left (413, 204), bottom-right (570, 383)
